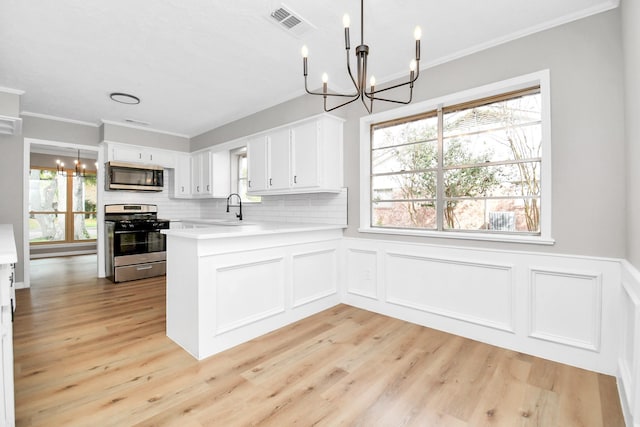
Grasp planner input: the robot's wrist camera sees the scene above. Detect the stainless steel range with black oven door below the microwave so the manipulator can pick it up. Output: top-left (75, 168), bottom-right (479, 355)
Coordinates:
top-left (104, 204), bottom-right (169, 282)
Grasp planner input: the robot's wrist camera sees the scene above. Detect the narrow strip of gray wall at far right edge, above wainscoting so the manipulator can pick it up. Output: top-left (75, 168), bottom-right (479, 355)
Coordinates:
top-left (621, 0), bottom-right (640, 269)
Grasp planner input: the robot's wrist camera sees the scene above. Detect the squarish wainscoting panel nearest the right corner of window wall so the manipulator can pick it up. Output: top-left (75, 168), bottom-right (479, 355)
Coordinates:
top-left (529, 267), bottom-right (602, 352)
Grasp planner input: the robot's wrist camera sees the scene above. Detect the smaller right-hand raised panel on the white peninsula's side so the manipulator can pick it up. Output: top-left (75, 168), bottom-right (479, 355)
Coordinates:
top-left (292, 249), bottom-right (338, 307)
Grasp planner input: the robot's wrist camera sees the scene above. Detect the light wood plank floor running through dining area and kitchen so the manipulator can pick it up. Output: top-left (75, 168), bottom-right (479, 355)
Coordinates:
top-left (14, 256), bottom-right (624, 427)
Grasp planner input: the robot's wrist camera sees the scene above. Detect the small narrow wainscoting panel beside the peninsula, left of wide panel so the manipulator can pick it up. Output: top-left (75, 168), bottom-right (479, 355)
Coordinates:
top-left (346, 248), bottom-right (378, 299)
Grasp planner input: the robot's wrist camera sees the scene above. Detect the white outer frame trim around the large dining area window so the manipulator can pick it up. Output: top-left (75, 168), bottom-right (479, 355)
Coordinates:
top-left (358, 70), bottom-right (555, 245)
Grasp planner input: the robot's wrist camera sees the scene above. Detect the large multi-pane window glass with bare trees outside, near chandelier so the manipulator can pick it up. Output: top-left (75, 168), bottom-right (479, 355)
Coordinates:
top-left (365, 72), bottom-right (548, 240)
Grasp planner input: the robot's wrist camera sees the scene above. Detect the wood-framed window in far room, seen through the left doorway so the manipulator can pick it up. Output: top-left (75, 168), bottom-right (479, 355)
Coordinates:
top-left (29, 168), bottom-right (97, 243)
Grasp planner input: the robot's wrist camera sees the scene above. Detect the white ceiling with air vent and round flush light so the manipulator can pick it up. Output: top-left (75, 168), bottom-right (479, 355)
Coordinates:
top-left (0, 0), bottom-right (619, 136)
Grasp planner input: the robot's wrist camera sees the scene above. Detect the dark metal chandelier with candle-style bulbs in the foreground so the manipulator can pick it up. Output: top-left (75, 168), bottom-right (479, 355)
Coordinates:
top-left (302, 0), bottom-right (422, 113)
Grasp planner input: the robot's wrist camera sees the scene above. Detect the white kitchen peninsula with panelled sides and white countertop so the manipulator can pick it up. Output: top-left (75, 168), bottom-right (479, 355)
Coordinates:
top-left (163, 221), bottom-right (345, 360)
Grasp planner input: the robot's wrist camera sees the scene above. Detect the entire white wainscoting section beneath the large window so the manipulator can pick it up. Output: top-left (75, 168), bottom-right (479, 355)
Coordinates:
top-left (341, 238), bottom-right (622, 375)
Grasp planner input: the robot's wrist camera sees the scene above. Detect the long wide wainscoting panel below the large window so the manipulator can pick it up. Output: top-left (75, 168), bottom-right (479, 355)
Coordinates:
top-left (385, 252), bottom-right (515, 333)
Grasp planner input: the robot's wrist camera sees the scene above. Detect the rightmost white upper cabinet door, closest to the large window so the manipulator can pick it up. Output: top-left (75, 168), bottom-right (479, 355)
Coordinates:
top-left (291, 121), bottom-right (320, 188)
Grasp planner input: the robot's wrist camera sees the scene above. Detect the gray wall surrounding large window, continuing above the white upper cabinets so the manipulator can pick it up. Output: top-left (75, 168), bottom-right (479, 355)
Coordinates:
top-left (192, 10), bottom-right (624, 257)
